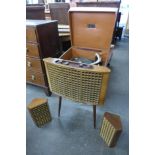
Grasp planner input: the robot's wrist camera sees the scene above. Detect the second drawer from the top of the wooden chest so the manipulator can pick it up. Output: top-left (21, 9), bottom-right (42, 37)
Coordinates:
top-left (26, 43), bottom-right (39, 58)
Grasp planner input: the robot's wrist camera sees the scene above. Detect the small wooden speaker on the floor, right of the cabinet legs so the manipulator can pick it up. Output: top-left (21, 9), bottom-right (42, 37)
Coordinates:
top-left (100, 112), bottom-right (122, 147)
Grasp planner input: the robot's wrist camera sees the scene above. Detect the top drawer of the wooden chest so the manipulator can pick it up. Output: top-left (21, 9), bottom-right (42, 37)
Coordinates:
top-left (26, 27), bottom-right (37, 42)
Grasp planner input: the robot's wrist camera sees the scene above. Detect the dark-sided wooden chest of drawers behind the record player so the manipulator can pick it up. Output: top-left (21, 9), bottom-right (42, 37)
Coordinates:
top-left (26, 20), bottom-right (61, 96)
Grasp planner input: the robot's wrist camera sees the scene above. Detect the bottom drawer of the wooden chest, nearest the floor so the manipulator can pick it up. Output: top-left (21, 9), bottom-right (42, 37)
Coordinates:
top-left (26, 70), bottom-right (45, 86)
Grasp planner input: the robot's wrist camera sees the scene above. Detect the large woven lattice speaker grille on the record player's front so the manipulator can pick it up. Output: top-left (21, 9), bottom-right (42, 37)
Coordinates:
top-left (47, 63), bottom-right (103, 104)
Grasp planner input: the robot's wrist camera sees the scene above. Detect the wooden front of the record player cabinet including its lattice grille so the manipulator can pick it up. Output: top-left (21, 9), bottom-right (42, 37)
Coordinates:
top-left (44, 58), bottom-right (110, 105)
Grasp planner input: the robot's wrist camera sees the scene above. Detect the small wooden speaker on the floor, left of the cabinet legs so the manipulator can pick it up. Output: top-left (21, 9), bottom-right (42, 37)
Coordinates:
top-left (27, 98), bottom-right (52, 127)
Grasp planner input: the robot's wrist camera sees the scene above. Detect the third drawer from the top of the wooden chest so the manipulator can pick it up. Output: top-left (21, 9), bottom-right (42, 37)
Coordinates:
top-left (26, 57), bottom-right (42, 72)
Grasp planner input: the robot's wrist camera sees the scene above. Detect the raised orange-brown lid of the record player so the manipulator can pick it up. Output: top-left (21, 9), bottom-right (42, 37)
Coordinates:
top-left (69, 7), bottom-right (117, 49)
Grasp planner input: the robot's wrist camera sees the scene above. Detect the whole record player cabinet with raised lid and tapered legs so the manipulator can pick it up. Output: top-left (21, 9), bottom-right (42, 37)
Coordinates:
top-left (44, 7), bottom-right (117, 127)
